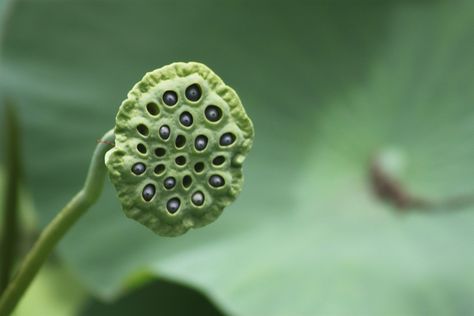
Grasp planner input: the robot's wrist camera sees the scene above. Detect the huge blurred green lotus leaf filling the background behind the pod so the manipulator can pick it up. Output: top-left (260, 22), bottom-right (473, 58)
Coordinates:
top-left (0, 0), bottom-right (474, 315)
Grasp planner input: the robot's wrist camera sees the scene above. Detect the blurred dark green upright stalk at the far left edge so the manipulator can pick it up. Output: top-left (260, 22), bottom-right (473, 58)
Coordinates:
top-left (0, 101), bottom-right (21, 295)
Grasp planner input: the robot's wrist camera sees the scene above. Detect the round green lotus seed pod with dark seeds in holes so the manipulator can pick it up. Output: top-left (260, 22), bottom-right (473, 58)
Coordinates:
top-left (105, 62), bottom-right (254, 236)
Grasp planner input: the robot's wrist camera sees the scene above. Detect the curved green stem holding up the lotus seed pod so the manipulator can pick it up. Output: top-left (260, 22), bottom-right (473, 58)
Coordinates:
top-left (0, 130), bottom-right (114, 316)
